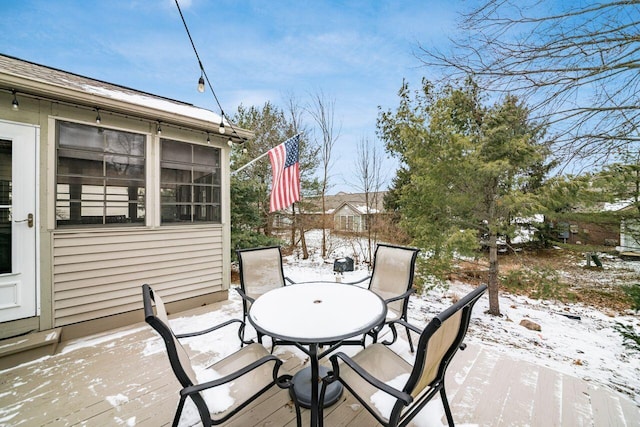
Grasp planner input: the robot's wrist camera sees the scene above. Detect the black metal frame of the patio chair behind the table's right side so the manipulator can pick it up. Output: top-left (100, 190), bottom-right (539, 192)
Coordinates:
top-left (346, 243), bottom-right (420, 353)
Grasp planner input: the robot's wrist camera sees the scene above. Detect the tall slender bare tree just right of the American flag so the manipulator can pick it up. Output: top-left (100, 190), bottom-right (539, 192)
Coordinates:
top-left (309, 92), bottom-right (340, 257)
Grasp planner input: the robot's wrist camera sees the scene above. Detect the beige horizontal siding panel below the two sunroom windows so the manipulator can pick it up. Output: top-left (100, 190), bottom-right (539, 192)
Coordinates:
top-left (52, 226), bottom-right (223, 327)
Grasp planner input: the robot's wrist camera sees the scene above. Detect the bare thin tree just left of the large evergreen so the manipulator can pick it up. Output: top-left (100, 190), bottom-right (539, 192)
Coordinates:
top-left (355, 138), bottom-right (383, 263)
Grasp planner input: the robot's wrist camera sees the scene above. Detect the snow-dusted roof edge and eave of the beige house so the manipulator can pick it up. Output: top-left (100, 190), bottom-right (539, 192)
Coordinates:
top-left (0, 54), bottom-right (251, 137)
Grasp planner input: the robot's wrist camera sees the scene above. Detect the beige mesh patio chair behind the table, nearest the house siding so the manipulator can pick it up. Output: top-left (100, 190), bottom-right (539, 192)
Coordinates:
top-left (236, 246), bottom-right (294, 350)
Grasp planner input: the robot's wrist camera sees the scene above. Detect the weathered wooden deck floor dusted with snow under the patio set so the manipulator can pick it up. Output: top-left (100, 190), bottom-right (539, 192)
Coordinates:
top-left (0, 301), bottom-right (640, 427)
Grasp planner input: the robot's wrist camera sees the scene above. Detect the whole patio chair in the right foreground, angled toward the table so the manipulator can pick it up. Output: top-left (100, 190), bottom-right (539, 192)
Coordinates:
top-left (319, 285), bottom-right (487, 427)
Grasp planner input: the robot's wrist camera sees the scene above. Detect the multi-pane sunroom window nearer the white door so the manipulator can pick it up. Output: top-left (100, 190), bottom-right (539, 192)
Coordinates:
top-left (55, 121), bottom-right (146, 227)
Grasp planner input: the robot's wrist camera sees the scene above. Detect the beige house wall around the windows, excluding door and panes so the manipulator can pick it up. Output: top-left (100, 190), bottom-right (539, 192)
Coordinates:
top-left (0, 91), bottom-right (230, 338)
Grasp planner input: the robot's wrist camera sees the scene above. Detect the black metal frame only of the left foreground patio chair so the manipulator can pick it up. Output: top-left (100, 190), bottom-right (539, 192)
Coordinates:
top-left (142, 284), bottom-right (301, 427)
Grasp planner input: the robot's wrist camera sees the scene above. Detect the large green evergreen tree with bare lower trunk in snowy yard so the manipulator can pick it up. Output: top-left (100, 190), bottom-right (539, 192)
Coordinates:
top-left (378, 79), bottom-right (550, 315)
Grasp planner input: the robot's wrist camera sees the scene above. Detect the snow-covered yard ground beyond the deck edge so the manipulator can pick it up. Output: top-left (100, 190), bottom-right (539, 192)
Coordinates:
top-left (284, 231), bottom-right (640, 406)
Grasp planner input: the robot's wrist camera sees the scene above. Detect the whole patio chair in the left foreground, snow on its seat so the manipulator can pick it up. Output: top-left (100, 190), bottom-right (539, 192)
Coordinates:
top-left (142, 284), bottom-right (301, 427)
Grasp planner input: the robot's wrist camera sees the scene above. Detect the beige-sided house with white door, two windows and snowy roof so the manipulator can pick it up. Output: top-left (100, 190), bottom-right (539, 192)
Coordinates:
top-left (0, 55), bottom-right (252, 348)
